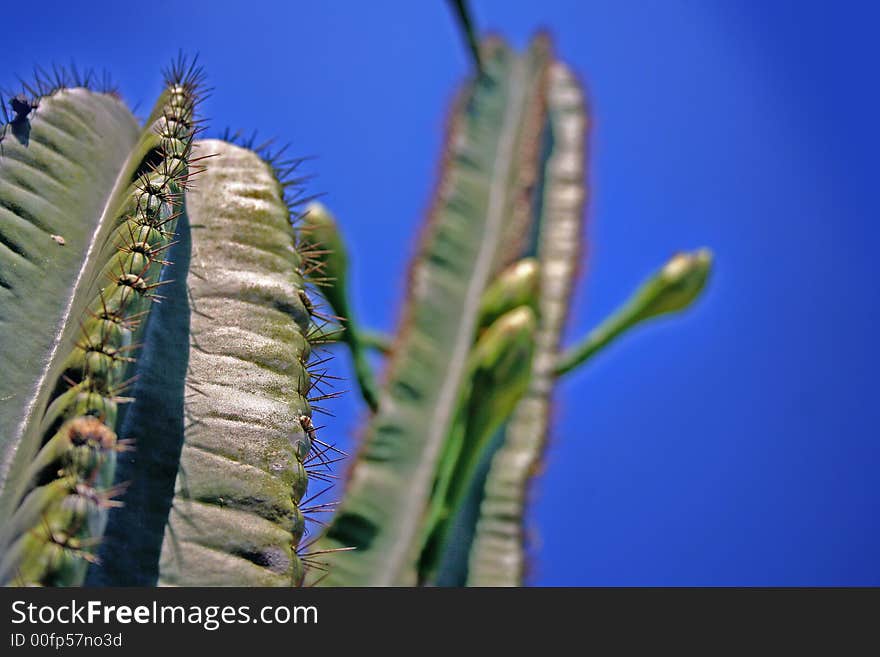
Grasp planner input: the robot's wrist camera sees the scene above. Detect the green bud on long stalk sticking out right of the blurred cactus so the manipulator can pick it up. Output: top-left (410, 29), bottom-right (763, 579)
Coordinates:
top-left (556, 248), bottom-right (712, 376)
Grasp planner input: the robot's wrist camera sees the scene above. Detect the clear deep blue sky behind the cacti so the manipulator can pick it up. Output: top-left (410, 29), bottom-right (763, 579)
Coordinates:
top-left (8, 0), bottom-right (880, 585)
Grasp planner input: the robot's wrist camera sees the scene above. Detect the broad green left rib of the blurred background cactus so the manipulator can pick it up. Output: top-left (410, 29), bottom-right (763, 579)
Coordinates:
top-left (319, 39), bottom-right (547, 586)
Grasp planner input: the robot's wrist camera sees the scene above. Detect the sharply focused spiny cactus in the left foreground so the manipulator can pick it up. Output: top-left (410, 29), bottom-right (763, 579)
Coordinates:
top-left (0, 58), bottom-right (328, 586)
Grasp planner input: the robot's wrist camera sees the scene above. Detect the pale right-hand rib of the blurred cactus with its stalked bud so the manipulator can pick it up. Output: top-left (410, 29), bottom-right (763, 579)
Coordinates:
top-left (458, 63), bottom-right (711, 586)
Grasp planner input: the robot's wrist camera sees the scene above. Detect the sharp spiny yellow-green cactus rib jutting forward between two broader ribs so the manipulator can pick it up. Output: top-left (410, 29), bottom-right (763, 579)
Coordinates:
top-left (0, 59), bottom-right (201, 585)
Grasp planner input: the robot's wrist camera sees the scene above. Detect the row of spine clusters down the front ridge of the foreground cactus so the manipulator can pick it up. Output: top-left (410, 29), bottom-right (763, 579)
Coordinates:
top-left (4, 57), bottom-right (204, 585)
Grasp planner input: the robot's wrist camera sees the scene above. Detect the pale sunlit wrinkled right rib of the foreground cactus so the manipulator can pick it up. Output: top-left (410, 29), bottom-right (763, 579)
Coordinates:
top-left (159, 140), bottom-right (316, 586)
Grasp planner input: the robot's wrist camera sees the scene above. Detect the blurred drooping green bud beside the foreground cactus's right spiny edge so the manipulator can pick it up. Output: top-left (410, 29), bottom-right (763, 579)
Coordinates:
top-left (302, 203), bottom-right (380, 411)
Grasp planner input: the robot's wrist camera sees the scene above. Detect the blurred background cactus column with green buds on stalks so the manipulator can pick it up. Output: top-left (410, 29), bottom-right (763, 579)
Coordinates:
top-left (306, 35), bottom-right (711, 586)
